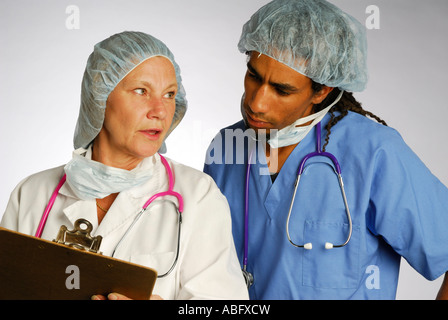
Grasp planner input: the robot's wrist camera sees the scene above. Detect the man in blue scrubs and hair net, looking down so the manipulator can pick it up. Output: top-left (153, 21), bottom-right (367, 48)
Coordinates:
top-left (204, 0), bottom-right (448, 299)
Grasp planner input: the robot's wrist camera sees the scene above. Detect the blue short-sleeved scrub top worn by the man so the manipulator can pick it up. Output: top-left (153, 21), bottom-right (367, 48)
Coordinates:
top-left (204, 112), bottom-right (448, 299)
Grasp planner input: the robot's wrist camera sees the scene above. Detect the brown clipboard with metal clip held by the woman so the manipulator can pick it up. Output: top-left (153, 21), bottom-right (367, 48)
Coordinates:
top-left (0, 220), bottom-right (157, 300)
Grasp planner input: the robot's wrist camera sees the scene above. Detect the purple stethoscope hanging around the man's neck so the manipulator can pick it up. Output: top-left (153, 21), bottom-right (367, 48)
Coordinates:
top-left (243, 122), bottom-right (353, 288)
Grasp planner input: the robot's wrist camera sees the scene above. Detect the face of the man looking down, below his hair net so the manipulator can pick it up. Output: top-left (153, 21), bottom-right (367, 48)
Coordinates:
top-left (241, 52), bottom-right (324, 134)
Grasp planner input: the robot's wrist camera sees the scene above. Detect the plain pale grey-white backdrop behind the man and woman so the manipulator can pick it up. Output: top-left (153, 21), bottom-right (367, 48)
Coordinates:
top-left (0, 0), bottom-right (448, 299)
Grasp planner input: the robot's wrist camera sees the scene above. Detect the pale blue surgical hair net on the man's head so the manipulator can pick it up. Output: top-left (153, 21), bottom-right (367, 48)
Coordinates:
top-left (238, 0), bottom-right (368, 91)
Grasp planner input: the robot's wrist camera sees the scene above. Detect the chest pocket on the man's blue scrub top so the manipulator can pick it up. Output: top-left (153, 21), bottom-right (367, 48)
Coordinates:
top-left (303, 220), bottom-right (360, 289)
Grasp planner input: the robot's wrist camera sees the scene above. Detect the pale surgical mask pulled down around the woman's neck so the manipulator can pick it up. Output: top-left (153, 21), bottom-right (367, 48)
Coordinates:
top-left (64, 147), bottom-right (153, 200)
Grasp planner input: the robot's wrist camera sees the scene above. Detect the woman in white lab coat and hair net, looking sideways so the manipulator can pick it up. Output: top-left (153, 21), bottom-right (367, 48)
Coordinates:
top-left (1, 32), bottom-right (248, 299)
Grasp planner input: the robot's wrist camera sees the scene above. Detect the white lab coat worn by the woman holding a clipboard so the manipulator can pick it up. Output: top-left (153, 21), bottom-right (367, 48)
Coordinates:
top-left (0, 154), bottom-right (248, 299)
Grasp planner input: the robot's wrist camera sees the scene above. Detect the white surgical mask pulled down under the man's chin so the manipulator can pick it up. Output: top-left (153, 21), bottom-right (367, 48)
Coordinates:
top-left (268, 91), bottom-right (344, 149)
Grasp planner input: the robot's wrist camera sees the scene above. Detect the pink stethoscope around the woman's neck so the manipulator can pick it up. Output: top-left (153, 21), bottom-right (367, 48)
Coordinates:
top-left (35, 155), bottom-right (184, 278)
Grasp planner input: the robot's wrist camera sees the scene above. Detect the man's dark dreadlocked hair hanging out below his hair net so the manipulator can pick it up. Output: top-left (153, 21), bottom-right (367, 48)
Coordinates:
top-left (311, 81), bottom-right (387, 152)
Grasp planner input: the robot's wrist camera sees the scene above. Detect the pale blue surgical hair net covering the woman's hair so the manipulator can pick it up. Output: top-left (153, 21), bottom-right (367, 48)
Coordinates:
top-left (74, 31), bottom-right (187, 152)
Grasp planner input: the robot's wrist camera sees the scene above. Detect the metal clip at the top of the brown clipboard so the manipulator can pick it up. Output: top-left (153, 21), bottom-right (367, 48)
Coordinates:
top-left (53, 219), bottom-right (103, 254)
